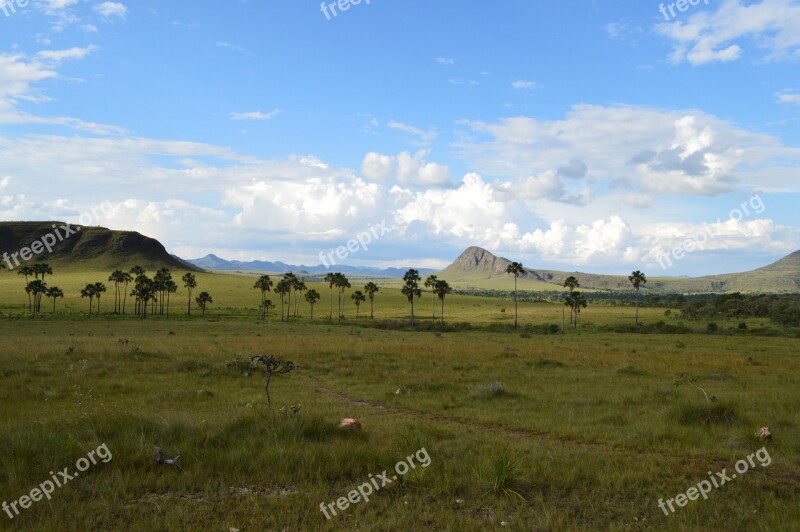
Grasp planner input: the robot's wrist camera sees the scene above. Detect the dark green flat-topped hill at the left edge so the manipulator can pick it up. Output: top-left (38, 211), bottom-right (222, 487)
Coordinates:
top-left (0, 222), bottom-right (199, 271)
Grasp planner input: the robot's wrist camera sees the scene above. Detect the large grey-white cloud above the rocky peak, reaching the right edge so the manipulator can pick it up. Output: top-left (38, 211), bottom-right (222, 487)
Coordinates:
top-left (455, 105), bottom-right (800, 198)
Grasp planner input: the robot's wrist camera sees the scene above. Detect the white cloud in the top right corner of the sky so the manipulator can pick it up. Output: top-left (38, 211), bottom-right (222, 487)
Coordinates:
top-left (656, 0), bottom-right (800, 65)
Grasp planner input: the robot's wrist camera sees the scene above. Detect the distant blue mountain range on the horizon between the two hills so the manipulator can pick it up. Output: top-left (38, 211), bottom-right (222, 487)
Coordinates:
top-left (186, 254), bottom-right (436, 278)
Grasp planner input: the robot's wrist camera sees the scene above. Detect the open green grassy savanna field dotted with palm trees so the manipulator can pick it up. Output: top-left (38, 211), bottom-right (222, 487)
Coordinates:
top-left (0, 272), bottom-right (800, 531)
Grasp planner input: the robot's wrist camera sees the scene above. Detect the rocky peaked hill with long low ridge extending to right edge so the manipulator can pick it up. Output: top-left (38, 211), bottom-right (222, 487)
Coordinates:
top-left (438, 247), bottom-right (800, 293)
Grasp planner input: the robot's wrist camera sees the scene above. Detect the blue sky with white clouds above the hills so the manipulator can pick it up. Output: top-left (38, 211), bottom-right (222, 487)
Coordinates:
top-left (0, 0), bottom-right (800, 277)
